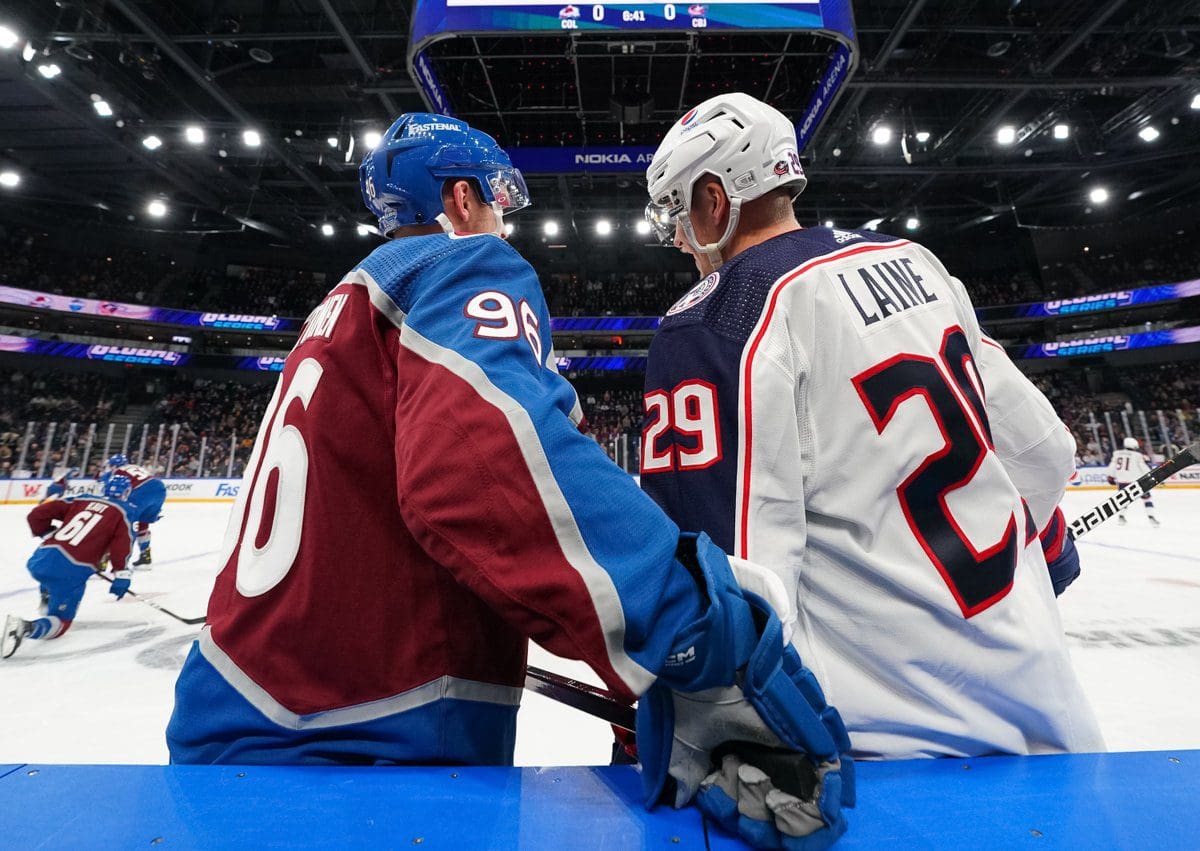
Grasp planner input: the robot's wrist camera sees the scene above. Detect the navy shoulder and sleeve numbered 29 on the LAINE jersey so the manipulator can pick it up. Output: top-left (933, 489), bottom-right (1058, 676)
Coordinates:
top-left (642, 228), bottom-right (895, 552)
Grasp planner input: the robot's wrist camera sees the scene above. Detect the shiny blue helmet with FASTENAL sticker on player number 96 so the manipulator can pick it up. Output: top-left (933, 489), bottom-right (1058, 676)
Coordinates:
top-left (359, 113), bottom-right (529, 236)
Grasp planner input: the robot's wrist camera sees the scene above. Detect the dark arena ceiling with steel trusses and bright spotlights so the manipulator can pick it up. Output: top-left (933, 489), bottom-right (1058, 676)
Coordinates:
top-left (0, 0), bottom-right (1200, 242)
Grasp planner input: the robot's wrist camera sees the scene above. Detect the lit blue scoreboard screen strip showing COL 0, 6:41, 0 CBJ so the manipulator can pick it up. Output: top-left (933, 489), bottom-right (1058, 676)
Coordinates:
top-left (412, 0), bottom-right (854, 37)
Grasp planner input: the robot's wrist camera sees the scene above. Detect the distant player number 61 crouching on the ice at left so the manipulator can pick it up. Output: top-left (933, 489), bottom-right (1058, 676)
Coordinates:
top-left (0, 479), bottom-right (133, 659)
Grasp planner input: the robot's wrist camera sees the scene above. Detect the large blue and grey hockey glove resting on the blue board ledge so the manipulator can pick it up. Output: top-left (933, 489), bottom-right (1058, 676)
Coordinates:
top-left (637, 535), bottom-right (854, 851)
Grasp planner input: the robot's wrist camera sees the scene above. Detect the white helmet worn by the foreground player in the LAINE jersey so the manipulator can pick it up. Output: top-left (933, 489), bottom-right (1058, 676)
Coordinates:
top-left (646, 91), bottom-right (809, 265)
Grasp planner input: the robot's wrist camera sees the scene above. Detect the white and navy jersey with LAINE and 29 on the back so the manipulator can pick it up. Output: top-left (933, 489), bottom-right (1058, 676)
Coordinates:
top-left (642, 228), bottom-right (1103, 759)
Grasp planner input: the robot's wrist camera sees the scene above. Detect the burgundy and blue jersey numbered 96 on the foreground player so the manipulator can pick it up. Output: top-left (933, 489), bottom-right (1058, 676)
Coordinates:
top-left (168, 234), bottom-right (700, 763)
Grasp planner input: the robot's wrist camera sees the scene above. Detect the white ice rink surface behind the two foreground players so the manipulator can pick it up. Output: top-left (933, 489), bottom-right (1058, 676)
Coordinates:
top-left (0, 490), bottom-right (1200, 765)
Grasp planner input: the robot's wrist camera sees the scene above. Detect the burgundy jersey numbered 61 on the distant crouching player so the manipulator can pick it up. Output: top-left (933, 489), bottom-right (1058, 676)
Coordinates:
top-left (28, 495), bottom-right (133, 570)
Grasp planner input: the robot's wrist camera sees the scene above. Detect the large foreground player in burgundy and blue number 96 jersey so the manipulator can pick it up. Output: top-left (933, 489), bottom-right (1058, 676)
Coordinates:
top-left (167, 114), bottom-right (853, 847)
